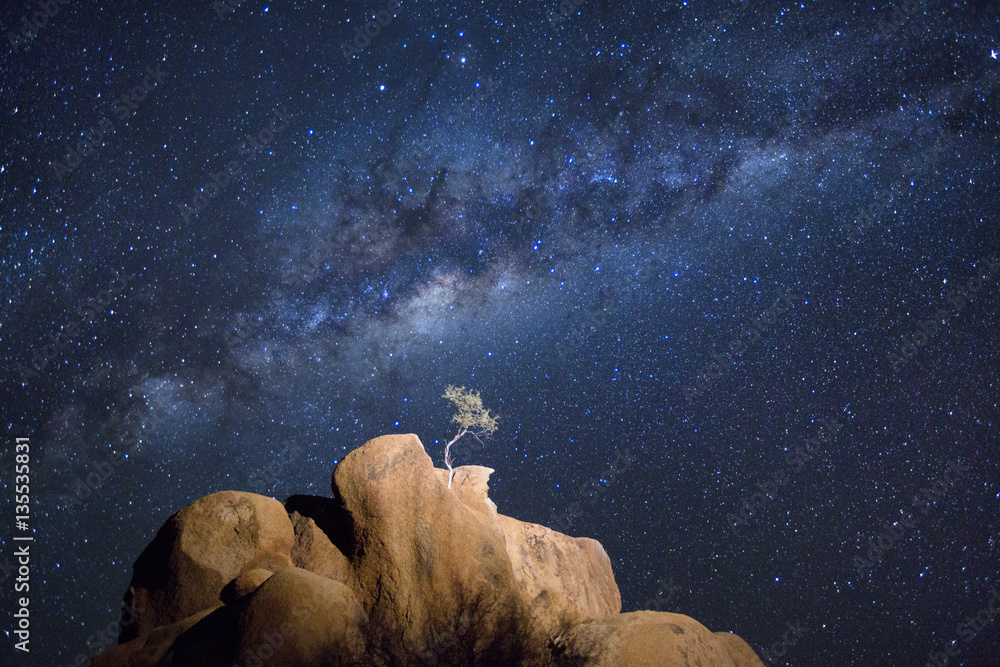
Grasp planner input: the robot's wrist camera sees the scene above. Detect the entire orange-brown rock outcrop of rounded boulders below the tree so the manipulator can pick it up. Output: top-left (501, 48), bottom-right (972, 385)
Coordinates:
top-left (91, 435), bottom-right (763, 667)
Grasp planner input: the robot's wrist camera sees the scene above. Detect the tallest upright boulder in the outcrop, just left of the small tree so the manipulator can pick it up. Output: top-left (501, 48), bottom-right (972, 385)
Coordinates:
top-left (333, 434), bottom-right (525, 664)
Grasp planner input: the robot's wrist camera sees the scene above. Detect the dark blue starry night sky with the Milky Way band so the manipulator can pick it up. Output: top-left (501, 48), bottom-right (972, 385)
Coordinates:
top-left (0, 0), bottom-right (1000, 666)
